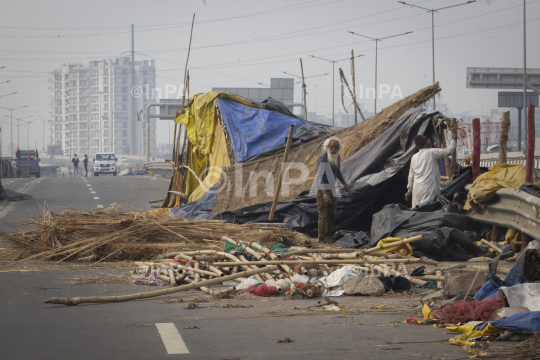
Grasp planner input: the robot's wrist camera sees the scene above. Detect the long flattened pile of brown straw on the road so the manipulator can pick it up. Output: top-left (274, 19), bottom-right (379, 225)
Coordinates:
top-left (0, 206), bottom-right (311, 261)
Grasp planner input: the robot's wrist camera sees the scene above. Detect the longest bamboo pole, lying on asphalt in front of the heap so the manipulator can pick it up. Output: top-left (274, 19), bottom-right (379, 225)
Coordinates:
top-left (43, 266), bottom-right (277, 306)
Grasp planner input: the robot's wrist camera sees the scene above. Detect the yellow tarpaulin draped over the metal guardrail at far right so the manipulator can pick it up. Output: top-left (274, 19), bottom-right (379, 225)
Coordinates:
top-left (463, 164), bottom-right (538, 210)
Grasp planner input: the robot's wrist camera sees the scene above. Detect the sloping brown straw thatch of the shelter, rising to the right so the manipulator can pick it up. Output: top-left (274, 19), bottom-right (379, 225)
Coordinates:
top-left (209, 83), bottom-right (440, 213)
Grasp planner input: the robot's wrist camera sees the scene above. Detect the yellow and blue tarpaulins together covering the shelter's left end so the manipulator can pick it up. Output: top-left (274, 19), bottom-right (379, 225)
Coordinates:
top-left (175, 91), bottom-right (322, 202)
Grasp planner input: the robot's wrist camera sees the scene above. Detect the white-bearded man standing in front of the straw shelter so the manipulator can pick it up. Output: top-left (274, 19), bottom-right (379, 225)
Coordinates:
top-left (315, 136), bottom-right (350, 243)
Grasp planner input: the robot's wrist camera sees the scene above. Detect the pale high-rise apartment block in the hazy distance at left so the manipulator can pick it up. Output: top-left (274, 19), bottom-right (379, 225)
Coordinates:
top-left (49, 57), bottom-right (157, 155)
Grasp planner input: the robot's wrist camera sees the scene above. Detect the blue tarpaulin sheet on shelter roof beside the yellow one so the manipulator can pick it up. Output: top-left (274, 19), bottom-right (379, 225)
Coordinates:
top-left (217, 98), bottom-right (310, 162)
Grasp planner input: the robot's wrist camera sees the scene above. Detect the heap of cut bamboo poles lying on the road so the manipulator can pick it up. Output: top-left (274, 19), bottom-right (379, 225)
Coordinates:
top-left (45, 235), bottom-right (437, 305)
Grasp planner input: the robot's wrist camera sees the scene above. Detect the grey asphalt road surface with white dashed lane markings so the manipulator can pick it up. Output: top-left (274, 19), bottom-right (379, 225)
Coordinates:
top-left (0, 176), bottom-right (476, 360)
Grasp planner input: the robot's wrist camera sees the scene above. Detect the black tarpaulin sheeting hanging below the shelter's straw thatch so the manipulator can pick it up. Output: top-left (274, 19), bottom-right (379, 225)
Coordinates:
top-left (214, 109), bottom-right (438, 236)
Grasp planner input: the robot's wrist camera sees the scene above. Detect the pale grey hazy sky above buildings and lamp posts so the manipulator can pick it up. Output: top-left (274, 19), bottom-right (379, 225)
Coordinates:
top-left (0, 0), bottom-right (540, 148)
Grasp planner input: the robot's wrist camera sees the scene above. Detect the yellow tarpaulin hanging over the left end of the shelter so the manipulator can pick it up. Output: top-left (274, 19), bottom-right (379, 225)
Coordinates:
top-left (174, 91), bottom-right (260, 201)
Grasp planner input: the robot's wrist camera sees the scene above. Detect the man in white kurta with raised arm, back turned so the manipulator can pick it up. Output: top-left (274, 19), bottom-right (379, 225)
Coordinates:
top-left (405, 129), bottom-right (457, 208)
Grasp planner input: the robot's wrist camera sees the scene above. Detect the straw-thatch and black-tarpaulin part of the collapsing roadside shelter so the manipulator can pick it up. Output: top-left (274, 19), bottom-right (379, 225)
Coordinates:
top-left (175, 83), bottom-right (440, 238)
